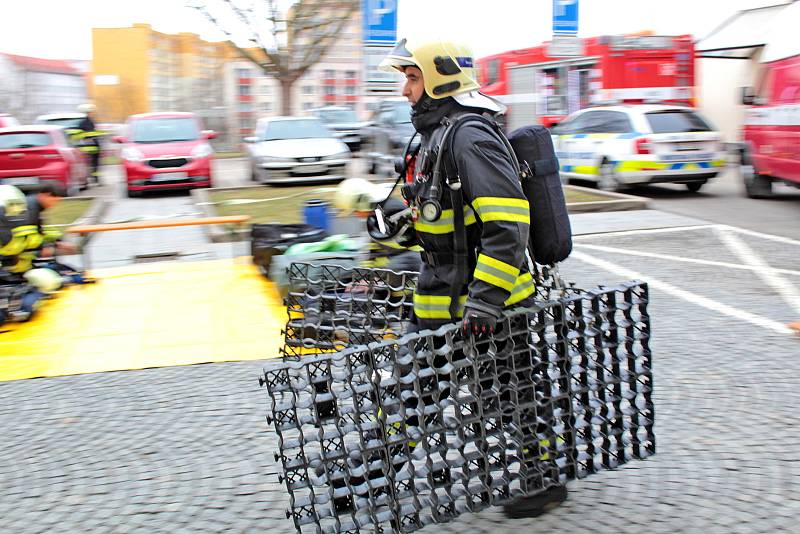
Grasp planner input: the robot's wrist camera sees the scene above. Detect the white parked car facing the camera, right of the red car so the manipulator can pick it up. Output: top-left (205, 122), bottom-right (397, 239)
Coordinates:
top-left (245, 117), bottom-right (351, 184)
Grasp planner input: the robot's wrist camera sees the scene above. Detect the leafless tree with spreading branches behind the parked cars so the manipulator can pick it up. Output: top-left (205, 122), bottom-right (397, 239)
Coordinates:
top-left (188, 0), bottom-right (359, 115)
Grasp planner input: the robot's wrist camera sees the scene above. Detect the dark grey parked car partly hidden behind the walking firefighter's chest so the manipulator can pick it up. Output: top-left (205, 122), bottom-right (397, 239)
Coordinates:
top-left (361, 98), bottom-right (414, 176)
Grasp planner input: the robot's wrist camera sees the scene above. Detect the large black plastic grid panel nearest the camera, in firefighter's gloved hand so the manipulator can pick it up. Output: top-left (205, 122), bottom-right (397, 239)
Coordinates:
top-left (262, 274), bottom-right (655, 532)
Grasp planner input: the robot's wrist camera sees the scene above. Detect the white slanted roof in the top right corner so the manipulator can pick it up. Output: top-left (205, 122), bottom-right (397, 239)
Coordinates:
top-left (696, 2), bottom-right (800, 62)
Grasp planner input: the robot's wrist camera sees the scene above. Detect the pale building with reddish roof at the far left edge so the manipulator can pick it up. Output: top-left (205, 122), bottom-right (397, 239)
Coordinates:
top-left (0, 53), bottom-right (88, 123)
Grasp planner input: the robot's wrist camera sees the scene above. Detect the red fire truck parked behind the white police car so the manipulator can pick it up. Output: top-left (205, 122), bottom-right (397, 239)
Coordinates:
top-left (477, 34), bottom-right (694, 129)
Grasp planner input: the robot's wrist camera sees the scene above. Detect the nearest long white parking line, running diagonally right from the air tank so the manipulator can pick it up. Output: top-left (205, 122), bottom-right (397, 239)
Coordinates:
top-left (570, 251), bottom-right (794, 334)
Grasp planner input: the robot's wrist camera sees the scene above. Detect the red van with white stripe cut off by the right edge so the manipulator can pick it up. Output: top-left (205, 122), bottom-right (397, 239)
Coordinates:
top-left (741, 51), bottom-right (800, 198)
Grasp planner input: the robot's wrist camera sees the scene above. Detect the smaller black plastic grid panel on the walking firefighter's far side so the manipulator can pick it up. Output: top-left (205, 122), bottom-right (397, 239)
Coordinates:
top-left (281, 263), bottom-right (418, 358)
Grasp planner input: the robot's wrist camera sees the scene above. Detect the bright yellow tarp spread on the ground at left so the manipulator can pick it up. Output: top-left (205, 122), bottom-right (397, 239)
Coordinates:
top-left (0, 258), bottom-right (286, 381)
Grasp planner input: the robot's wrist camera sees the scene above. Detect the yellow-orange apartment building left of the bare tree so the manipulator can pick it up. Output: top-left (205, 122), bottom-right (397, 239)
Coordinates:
top-left (90, 24), bottom-right (233, 128)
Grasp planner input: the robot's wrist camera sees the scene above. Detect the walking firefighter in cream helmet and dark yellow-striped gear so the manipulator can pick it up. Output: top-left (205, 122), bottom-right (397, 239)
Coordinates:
top-left (376, 39), bottom-right (566, 517)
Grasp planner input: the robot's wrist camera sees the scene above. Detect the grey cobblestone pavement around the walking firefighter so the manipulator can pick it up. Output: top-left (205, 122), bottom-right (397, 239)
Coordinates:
top-left (0, 224), bottom-right (800, 534)
